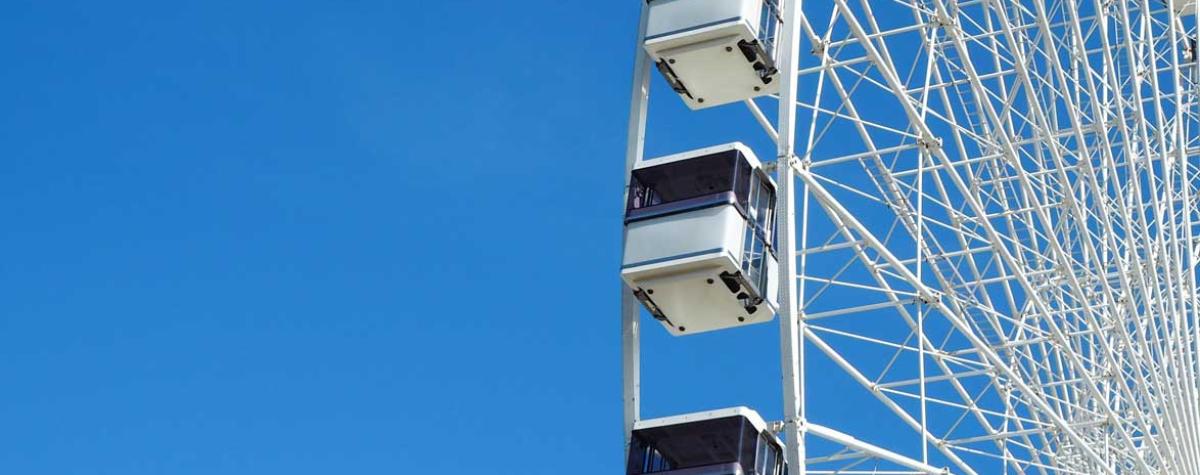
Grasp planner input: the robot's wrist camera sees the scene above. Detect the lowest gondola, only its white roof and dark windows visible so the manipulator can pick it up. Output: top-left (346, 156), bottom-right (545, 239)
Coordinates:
top-left (625, 408), bottom-right (787, 475)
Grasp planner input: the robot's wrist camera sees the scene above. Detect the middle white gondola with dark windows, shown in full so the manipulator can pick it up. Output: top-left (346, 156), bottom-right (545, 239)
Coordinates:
top-left (620, 143), bottom-right (779, 336)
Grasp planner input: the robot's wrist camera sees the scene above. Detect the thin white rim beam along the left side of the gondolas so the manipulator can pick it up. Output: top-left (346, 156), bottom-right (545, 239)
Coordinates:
top-left (620, 0), bottom-right (650, 458)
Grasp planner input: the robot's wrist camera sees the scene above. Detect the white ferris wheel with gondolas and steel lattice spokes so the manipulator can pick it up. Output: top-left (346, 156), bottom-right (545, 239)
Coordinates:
top-left (622, 0), bottom-right (1200, 475)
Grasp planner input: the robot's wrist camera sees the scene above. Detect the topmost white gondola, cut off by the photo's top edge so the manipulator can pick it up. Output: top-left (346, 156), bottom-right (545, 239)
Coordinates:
top-left (646, 0), bottom-right (780, 109)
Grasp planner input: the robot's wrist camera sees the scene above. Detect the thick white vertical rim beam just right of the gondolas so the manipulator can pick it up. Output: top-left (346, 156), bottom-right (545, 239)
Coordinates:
top-left (775, 0), bottom-right (808, 475)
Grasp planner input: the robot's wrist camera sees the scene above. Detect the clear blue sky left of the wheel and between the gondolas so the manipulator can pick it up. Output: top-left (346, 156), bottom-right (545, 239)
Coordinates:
top-left (0, 0), bottom-right (902, 475)
